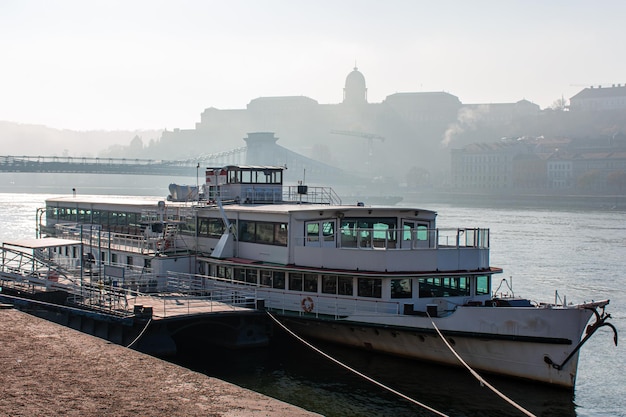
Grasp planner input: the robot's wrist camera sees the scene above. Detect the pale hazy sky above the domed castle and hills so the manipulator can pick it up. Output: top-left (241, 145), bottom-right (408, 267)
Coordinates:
top-left (0, 0), bottom-right (626, 130)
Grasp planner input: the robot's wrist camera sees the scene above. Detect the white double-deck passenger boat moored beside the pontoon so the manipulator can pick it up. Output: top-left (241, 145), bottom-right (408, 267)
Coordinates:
top-left (41, 166), bottom-right (617, 388)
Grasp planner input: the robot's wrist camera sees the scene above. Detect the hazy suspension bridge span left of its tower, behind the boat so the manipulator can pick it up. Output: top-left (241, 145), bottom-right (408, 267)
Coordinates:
top-left (0, 152), bottom-right (245, 177)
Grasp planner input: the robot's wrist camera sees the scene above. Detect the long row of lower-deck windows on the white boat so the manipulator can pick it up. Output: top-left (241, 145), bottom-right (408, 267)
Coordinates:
top-left (215, 265), bottom-right (490, 298)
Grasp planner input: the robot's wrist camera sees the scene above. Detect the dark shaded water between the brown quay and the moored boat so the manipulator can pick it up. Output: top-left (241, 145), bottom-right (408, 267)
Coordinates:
top-left (171, 331), bottom-right (576, 417)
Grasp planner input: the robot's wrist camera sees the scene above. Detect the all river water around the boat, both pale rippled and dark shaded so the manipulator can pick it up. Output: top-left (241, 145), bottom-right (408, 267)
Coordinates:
top-left (0, 190), bottom-right (626, 417)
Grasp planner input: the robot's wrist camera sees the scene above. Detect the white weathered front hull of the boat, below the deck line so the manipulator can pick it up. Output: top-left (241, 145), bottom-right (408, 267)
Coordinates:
top-left (280, 308), bottom-right (592, 389)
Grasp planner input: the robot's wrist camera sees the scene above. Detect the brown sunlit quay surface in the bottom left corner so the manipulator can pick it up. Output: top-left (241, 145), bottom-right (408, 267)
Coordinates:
top-left (0, 305), bottom-right (319, 417)
